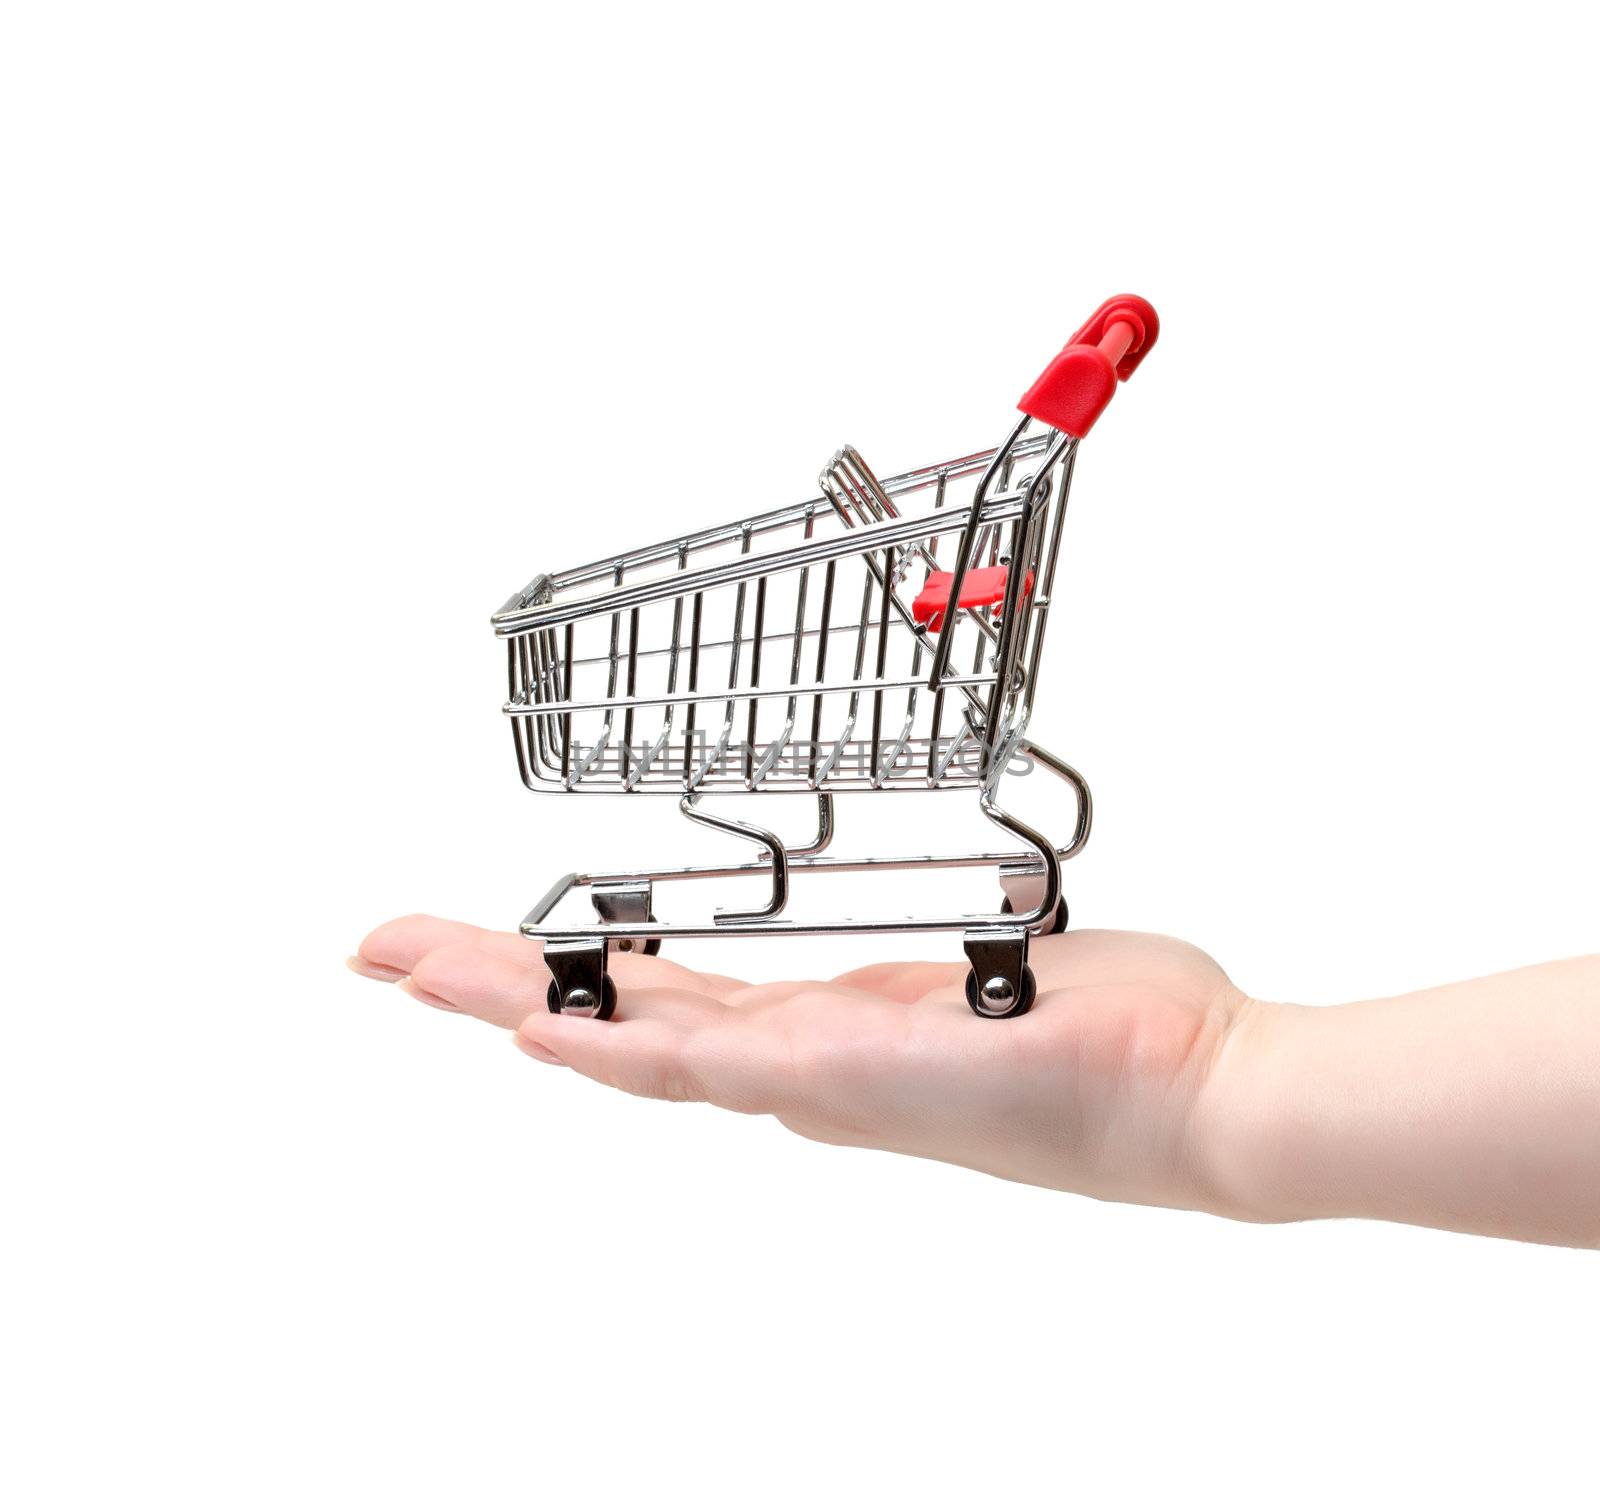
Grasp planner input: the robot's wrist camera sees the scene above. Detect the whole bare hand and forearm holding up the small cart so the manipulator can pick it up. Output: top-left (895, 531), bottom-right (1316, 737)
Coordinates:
top-left (350, 915), bottom-right (1600, 1248)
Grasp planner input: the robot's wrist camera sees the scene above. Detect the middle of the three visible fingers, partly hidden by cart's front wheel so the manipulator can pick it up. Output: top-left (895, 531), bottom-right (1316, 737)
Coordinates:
top-left (406, 937), bottom-right (723, 1030)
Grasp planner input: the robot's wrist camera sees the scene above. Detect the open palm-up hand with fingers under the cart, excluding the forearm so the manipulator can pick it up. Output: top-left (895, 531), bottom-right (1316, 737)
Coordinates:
top-left (352, 917), bottom-right (1243, 1206)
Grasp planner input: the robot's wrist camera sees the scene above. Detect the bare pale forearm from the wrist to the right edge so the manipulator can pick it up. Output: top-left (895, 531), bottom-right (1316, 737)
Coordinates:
top-left (1200, 957), bottom-right (1600, 1246)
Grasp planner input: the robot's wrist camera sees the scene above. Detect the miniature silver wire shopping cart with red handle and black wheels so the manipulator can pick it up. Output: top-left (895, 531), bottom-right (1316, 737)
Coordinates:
top-left (493, 294), bottom-right (1158, 1017)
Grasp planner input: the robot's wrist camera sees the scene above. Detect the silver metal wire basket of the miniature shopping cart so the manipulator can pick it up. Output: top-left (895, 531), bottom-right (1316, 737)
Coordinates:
top-left (494, 424), bottom-right (1072, 793)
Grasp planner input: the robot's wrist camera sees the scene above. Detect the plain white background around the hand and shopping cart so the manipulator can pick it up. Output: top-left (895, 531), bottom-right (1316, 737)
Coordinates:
top-left (0, 3), bottom-right (1600, 1504)
